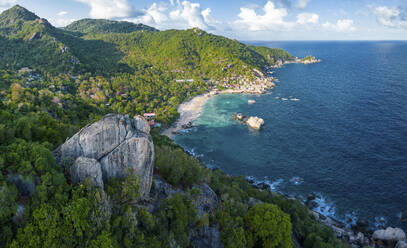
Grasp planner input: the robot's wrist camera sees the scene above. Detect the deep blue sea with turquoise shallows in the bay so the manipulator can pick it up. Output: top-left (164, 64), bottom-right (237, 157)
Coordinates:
top-left (176, 42), bottom-right (407, 228)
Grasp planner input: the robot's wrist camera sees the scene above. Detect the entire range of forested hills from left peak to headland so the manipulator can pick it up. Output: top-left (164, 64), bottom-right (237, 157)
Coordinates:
top-left (0, 5), bottom-right (291, 77)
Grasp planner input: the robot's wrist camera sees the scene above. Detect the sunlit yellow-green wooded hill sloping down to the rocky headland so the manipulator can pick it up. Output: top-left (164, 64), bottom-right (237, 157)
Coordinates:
top-left (84, 28), bottom-right (292, 79)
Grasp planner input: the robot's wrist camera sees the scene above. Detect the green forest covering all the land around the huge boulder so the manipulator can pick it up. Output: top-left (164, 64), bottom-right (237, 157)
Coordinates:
top-left (0, 6), bottom-right (347, 248)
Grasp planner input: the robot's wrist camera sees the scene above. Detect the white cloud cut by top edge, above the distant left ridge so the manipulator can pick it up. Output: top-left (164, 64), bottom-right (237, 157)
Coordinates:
top-left (76, 0), bottom-right (133, 19)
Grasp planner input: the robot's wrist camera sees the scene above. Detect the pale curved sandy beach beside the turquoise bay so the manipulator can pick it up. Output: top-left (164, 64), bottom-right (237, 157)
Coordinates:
top-left (161, 89), bottom-right (242, 139)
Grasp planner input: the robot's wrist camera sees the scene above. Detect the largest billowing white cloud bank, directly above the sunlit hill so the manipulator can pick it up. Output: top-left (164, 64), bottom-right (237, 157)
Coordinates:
top-left (127, 0), bottom-right (220, 30)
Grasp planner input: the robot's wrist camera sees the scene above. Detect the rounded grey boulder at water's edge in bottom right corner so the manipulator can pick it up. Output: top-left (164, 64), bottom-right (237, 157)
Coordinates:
top-left (372, 227), bottom-right (406, 247)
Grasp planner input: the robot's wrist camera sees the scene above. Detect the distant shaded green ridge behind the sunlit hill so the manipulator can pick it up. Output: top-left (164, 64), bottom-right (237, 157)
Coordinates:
top-left (64, 19), bottom-right (158, 34)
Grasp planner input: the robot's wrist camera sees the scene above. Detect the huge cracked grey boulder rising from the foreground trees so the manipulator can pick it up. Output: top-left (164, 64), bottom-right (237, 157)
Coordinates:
top-left (54, 114), bottom-right (154, 197)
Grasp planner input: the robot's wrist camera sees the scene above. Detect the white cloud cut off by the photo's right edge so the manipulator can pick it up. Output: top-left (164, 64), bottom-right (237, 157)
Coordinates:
top-left (373, 6), bottom-right (407, 28)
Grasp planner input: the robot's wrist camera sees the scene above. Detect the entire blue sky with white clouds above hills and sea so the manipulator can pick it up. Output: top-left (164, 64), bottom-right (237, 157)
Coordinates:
top-left (0, 0), bottom-right (407, 40)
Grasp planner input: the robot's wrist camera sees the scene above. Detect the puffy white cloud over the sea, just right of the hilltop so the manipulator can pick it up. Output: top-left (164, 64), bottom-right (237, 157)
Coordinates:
top-left (235, 1), bottom-right (295, 31)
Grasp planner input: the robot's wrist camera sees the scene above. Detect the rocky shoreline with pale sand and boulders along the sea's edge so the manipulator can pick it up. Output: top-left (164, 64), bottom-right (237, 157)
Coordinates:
top-left (163, 56), bottom-right (407, 248)
